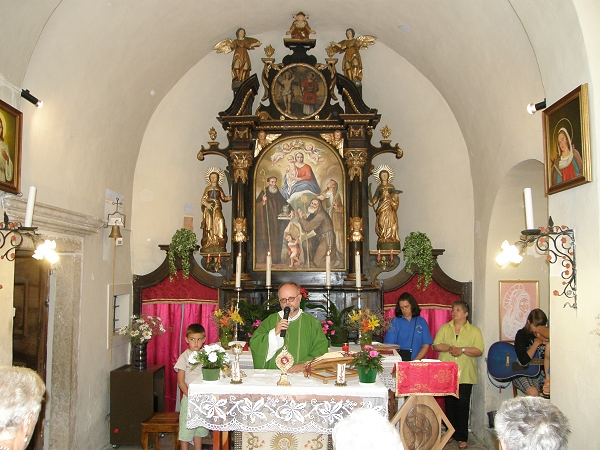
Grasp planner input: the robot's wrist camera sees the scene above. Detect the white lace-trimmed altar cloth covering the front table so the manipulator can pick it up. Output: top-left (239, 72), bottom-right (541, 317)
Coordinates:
top-left (187, 369), bottom-right (388, 434)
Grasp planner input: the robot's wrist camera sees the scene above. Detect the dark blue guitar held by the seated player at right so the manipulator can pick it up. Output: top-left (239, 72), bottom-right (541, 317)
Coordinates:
top-left (487, 341), bottom-right (544, 381)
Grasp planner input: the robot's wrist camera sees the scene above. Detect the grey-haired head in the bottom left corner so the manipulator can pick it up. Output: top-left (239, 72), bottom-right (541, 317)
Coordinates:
top-left (0, 367), bottom-right (46, 450)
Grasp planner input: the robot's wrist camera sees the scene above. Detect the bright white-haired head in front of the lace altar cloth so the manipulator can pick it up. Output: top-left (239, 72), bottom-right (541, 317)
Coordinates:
top-left (331, 408), bottom-right (404, 450)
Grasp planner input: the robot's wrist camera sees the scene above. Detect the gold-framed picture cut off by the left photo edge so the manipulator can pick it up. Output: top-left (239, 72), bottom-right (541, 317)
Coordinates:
top-left (0, 100), bottom-right (23, 194)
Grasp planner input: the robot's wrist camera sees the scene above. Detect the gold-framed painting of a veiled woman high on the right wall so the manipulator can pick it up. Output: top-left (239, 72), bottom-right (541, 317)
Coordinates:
top-left (543, 84), bottom-right (592, 194)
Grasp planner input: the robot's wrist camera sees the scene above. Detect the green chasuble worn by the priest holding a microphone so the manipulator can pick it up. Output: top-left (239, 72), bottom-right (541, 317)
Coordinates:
top-left (250, 312), bottom-right (329, 369)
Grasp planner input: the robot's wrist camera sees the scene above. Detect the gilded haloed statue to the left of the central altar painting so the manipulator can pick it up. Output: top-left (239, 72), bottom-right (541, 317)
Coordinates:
top-left (200, 167), bottom-right (231, 253)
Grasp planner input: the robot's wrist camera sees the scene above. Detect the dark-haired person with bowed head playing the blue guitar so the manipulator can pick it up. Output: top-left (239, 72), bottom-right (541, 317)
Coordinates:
top-left (513, 308), bottom-right (550, 397)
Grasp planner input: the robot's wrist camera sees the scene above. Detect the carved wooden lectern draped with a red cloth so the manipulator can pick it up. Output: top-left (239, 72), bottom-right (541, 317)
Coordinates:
top-left (392, 361), bottom-right (460, 449)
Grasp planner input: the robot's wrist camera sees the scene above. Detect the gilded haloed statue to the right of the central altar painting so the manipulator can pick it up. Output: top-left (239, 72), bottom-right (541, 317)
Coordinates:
top-left (369, 165), bottom-right (402, 250)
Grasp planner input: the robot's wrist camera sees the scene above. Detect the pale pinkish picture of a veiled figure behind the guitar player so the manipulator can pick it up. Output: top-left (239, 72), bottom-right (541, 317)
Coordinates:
top-left (500, 280), bottom-right (540, 341)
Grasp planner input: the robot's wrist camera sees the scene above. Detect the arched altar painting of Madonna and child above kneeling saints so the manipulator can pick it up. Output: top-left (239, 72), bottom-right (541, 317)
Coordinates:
top-left (253, 136), bottom-right (346, 271)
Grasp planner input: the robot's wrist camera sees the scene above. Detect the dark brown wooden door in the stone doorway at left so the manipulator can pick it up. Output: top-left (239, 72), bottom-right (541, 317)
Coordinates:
top-left (13, 251), bottom-right (50, 450)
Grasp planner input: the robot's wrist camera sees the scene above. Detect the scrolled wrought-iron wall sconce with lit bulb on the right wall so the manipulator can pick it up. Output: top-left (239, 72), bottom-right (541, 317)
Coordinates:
top-left (496, 217), bottom-right (577, 309)
